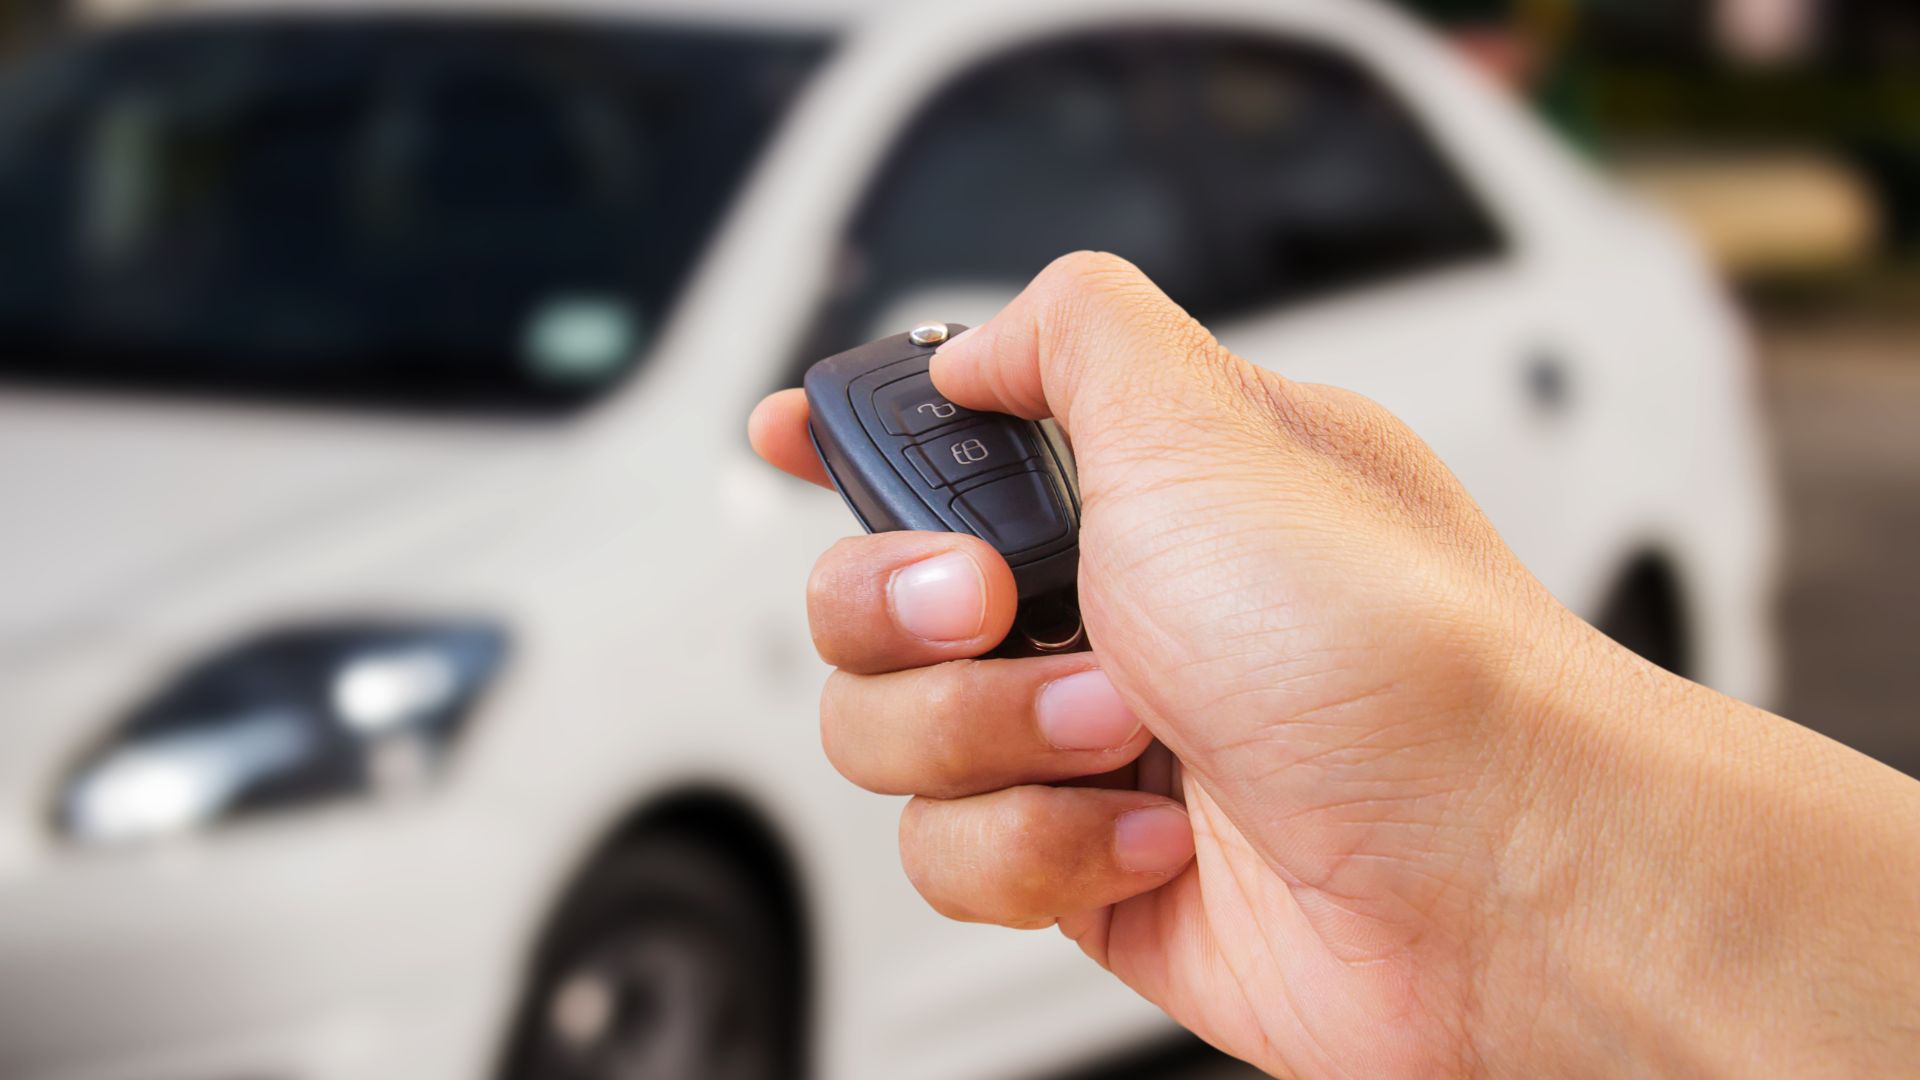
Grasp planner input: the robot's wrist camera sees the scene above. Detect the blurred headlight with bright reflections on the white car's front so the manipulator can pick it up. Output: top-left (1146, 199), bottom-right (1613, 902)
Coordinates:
top-left (52, 621), bottom-right (509, 846)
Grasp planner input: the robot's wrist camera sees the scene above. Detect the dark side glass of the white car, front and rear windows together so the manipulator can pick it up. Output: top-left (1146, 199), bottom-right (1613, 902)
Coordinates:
top-left (797, 27), bottom-right (1501, 363)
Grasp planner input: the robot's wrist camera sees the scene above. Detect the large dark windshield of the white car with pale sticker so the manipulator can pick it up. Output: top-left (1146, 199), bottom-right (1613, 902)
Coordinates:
top-left (0, 17), bottom-right (826, 409)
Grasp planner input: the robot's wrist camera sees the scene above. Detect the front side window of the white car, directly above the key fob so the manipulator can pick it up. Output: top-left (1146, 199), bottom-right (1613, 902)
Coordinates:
top-left (804, 35), bottom-right (1206, 357)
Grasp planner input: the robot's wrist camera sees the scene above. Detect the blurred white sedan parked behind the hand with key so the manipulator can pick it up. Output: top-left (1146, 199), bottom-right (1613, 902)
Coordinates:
top-left (0, 0), bottom-right (1774, 1080)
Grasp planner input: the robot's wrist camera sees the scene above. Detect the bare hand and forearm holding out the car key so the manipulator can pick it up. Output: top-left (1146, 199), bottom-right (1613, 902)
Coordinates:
top-left (749, 254), bottom-right (1920, 1076)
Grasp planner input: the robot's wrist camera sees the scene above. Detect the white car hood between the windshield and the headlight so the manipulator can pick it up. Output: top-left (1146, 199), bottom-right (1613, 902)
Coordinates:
top-left (0, 392), bottom-right (551, 657)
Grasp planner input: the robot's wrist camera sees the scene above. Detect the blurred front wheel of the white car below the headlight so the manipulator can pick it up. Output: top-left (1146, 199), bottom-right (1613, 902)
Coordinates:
top-left (505, 836), bottom-right (804, 1080)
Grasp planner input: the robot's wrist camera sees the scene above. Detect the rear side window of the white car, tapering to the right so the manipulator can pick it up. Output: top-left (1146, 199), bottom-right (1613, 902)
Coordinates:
top-left (1190, 38), bottom-right (1505, 317)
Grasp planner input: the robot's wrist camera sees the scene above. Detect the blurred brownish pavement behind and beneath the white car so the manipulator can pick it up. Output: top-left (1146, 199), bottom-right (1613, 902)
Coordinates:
top-left (1066, 303), bottom-right (1920, 1080)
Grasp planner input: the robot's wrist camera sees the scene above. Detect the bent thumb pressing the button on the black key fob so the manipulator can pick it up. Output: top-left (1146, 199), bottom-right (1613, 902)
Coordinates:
top-left (933, 252), bottom-right (1258, 451)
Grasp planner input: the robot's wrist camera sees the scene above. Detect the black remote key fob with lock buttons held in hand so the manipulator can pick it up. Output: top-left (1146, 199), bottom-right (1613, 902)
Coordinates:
top-left (806, 323), bottom-right (1087, 657)
